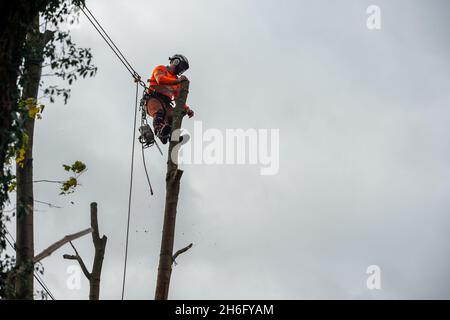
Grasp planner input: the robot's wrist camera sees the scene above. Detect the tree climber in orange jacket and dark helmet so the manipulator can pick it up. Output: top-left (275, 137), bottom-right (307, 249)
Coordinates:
top-left (146, 54), bottom-right (194, 144)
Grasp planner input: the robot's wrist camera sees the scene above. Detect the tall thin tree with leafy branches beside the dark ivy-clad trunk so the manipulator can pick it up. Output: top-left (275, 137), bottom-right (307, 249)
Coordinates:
top-left (15, 3), bottom-right (96, 299)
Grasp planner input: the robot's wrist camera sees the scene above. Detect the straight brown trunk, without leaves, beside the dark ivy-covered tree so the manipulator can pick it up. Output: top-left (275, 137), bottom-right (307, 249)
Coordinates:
top-left (15, 17), bottom-right (52, 300)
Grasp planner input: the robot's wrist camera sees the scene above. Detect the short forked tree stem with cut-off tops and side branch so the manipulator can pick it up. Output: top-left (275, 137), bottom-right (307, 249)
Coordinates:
top-left (63, 202), bottom-right (108, 300)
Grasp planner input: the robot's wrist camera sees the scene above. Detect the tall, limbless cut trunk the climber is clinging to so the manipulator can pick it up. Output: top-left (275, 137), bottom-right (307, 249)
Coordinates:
top-left (155, 81), bottom-right (189, 300)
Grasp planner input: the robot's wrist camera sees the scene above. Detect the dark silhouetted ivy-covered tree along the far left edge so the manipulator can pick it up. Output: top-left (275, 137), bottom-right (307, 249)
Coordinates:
top-left (0, 0), bottom-right (84, 297)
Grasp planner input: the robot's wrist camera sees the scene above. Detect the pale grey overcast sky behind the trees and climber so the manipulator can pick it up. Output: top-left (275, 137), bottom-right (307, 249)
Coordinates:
top-left (4, 0), bottom-right (450, 299)
